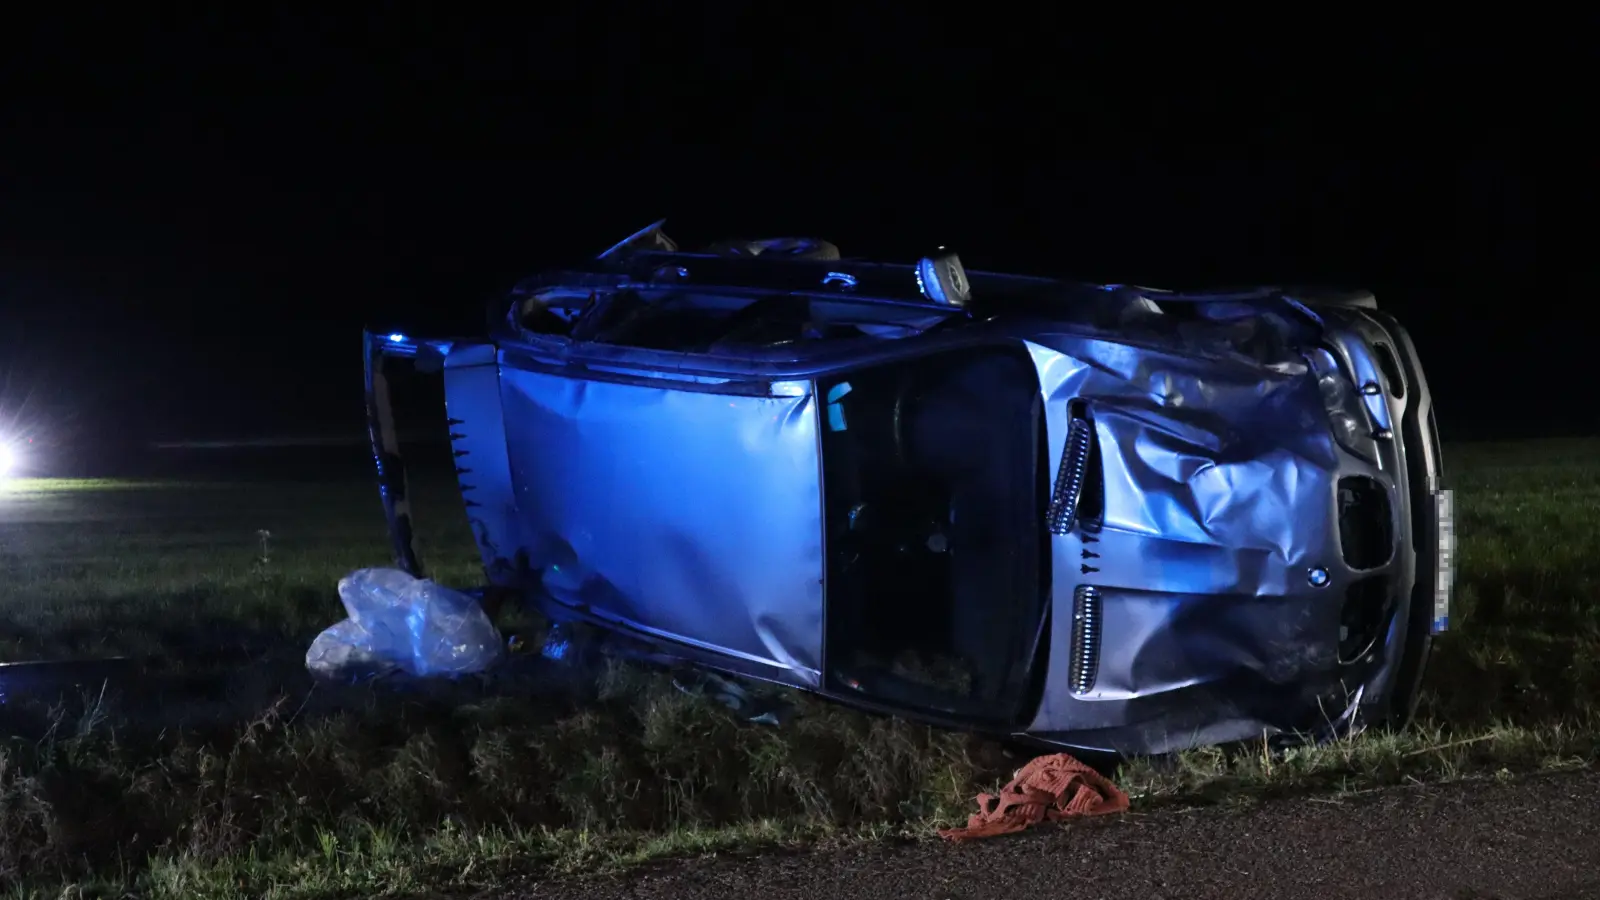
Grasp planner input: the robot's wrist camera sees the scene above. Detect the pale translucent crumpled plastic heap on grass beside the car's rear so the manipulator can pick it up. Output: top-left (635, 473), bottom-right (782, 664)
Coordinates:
top-left (306, 569), bottom-right (502, 677)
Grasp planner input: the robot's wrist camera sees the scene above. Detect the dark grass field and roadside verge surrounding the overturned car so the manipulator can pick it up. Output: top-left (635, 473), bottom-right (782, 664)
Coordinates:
top-left (0, 440), bottom-right (1600, 897)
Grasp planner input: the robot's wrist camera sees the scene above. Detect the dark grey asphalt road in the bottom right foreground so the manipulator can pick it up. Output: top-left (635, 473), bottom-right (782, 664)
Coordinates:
top-left (510, 770), bottom-right (1600, 900)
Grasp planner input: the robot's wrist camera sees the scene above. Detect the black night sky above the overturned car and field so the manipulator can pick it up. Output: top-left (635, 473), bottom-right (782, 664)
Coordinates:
top-left (0, 5), bottom-right (1548, 451)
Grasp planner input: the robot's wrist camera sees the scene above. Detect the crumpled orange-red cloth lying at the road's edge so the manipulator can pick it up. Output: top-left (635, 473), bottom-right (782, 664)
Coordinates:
top-left (939, 753), bottom-right (1128, 841)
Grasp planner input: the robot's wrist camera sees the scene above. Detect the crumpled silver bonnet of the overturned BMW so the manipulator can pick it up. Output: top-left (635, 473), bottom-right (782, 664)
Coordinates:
top-left (1027, 336), bottom-right (1414, 751)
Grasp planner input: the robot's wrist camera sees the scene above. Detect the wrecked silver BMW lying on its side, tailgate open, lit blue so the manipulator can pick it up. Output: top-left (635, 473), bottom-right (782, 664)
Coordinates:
top-left (365, 223), bottom-right (1453, 753)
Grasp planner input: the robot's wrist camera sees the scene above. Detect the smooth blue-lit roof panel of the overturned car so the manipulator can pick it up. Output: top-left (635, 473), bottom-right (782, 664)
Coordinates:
top-left (499, 360), bottom-right (822, 685)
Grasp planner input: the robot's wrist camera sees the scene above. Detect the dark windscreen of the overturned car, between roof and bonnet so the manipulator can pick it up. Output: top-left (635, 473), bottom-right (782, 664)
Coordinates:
top-left (818, 346), bottom-right (1050, 721)
